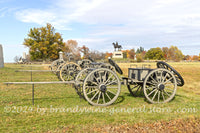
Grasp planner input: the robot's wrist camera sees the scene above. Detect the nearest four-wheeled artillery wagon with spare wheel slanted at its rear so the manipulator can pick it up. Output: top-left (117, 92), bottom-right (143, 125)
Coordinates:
top-left (6, 59), bottom-right (184, 106)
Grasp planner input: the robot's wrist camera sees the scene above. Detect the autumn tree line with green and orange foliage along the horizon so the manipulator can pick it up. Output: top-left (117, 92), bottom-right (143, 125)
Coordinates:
top-left (20, 23), bottom-right (200, 62)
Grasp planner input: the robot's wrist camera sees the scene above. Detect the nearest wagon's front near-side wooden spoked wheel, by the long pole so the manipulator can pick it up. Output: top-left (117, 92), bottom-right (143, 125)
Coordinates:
top-left (83, 68), bottom-right (121, 106)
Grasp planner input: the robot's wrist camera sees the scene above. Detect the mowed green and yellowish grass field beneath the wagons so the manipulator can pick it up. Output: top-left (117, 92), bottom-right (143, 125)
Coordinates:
top-left (0, 62), bottom-right (200, 132)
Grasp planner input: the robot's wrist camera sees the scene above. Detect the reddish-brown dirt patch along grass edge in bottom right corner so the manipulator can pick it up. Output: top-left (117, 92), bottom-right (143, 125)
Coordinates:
top-left (84, 118), bottom-right (200, 133)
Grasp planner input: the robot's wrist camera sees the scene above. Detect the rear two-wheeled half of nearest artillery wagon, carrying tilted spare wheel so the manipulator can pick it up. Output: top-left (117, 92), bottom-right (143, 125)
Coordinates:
top-left (124, 61), bottom-right (184, 103)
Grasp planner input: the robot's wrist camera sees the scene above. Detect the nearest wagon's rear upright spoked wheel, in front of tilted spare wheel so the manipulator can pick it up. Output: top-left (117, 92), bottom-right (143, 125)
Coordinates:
top-left (143, 68), bottom-right (177, 103)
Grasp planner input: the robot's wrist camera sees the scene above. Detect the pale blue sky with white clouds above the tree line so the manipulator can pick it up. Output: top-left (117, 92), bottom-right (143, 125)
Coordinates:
top-left (0, 0), bottom-right (200, 62)
